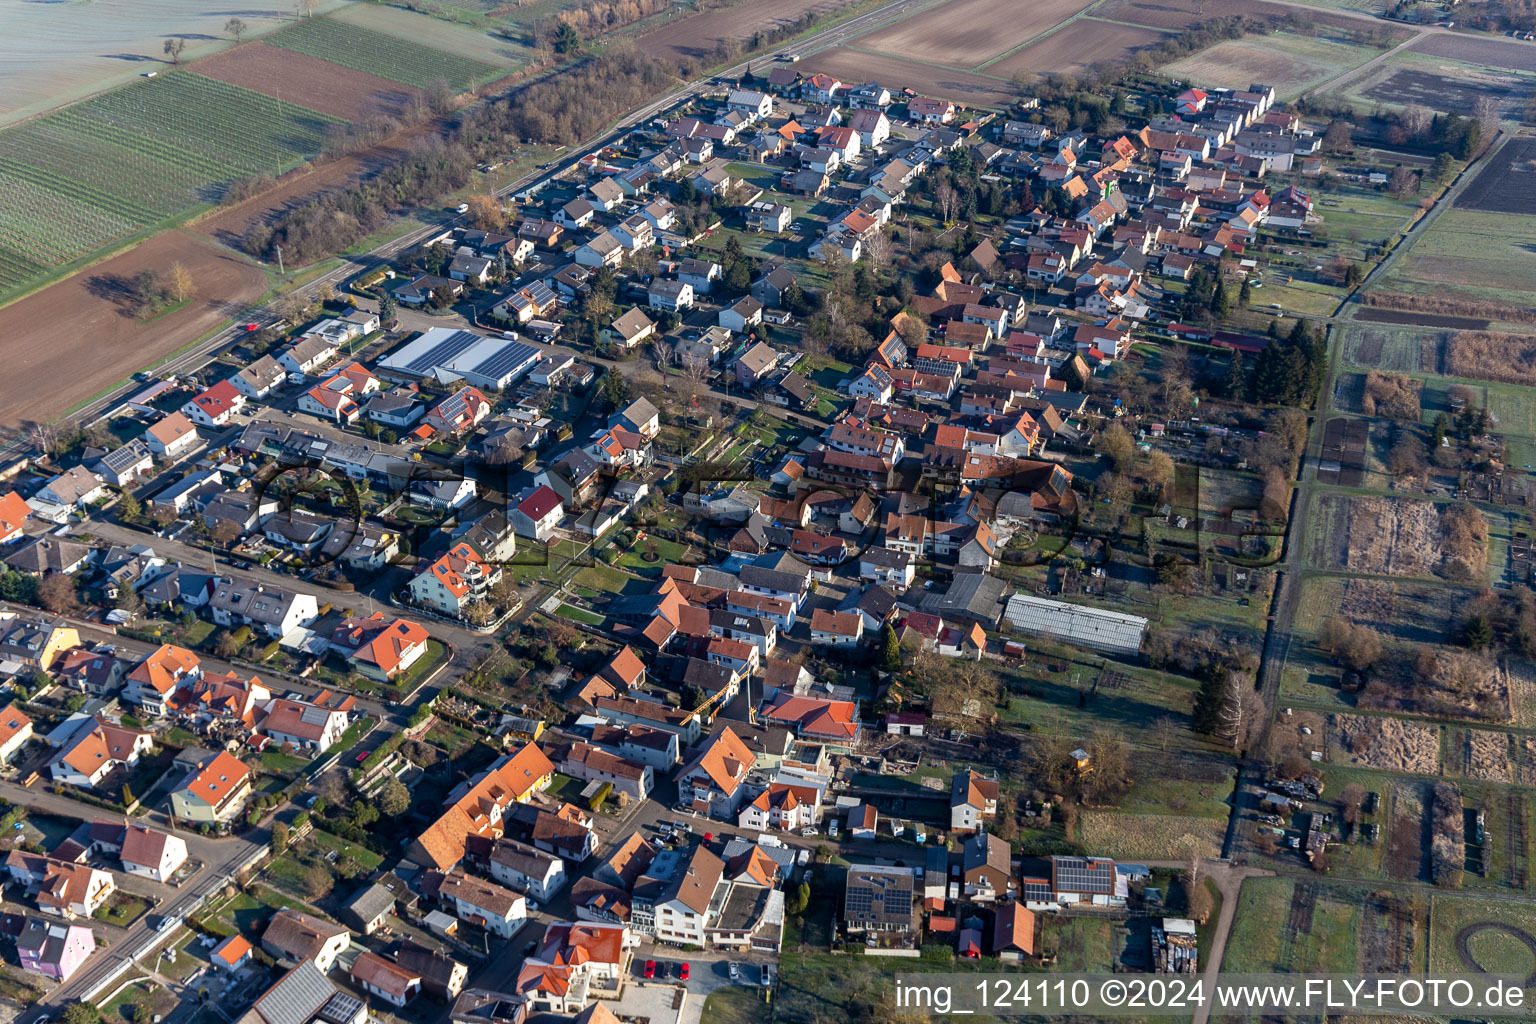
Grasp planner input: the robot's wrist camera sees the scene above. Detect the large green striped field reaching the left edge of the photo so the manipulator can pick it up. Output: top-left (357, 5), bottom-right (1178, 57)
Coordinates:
top-left (0, 72), bottom-right (338, 290)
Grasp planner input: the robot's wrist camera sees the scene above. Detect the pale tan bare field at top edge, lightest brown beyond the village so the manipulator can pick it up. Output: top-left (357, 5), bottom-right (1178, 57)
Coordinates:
top-left (859, 0), bottom-right (1091, 68)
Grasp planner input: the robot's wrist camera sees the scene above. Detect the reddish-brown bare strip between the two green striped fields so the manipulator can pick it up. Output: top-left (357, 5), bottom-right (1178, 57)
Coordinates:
top-left (192, 43), bottom-right (416, 121)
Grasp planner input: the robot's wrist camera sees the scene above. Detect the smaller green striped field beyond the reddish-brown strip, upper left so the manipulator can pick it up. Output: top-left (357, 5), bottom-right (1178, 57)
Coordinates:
top-left (264, 18), bottom-right (505, 89)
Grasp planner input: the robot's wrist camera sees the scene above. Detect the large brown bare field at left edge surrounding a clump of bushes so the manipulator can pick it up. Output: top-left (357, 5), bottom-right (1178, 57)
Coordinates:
top-left (0, 232), bottom-right (267, 428)
